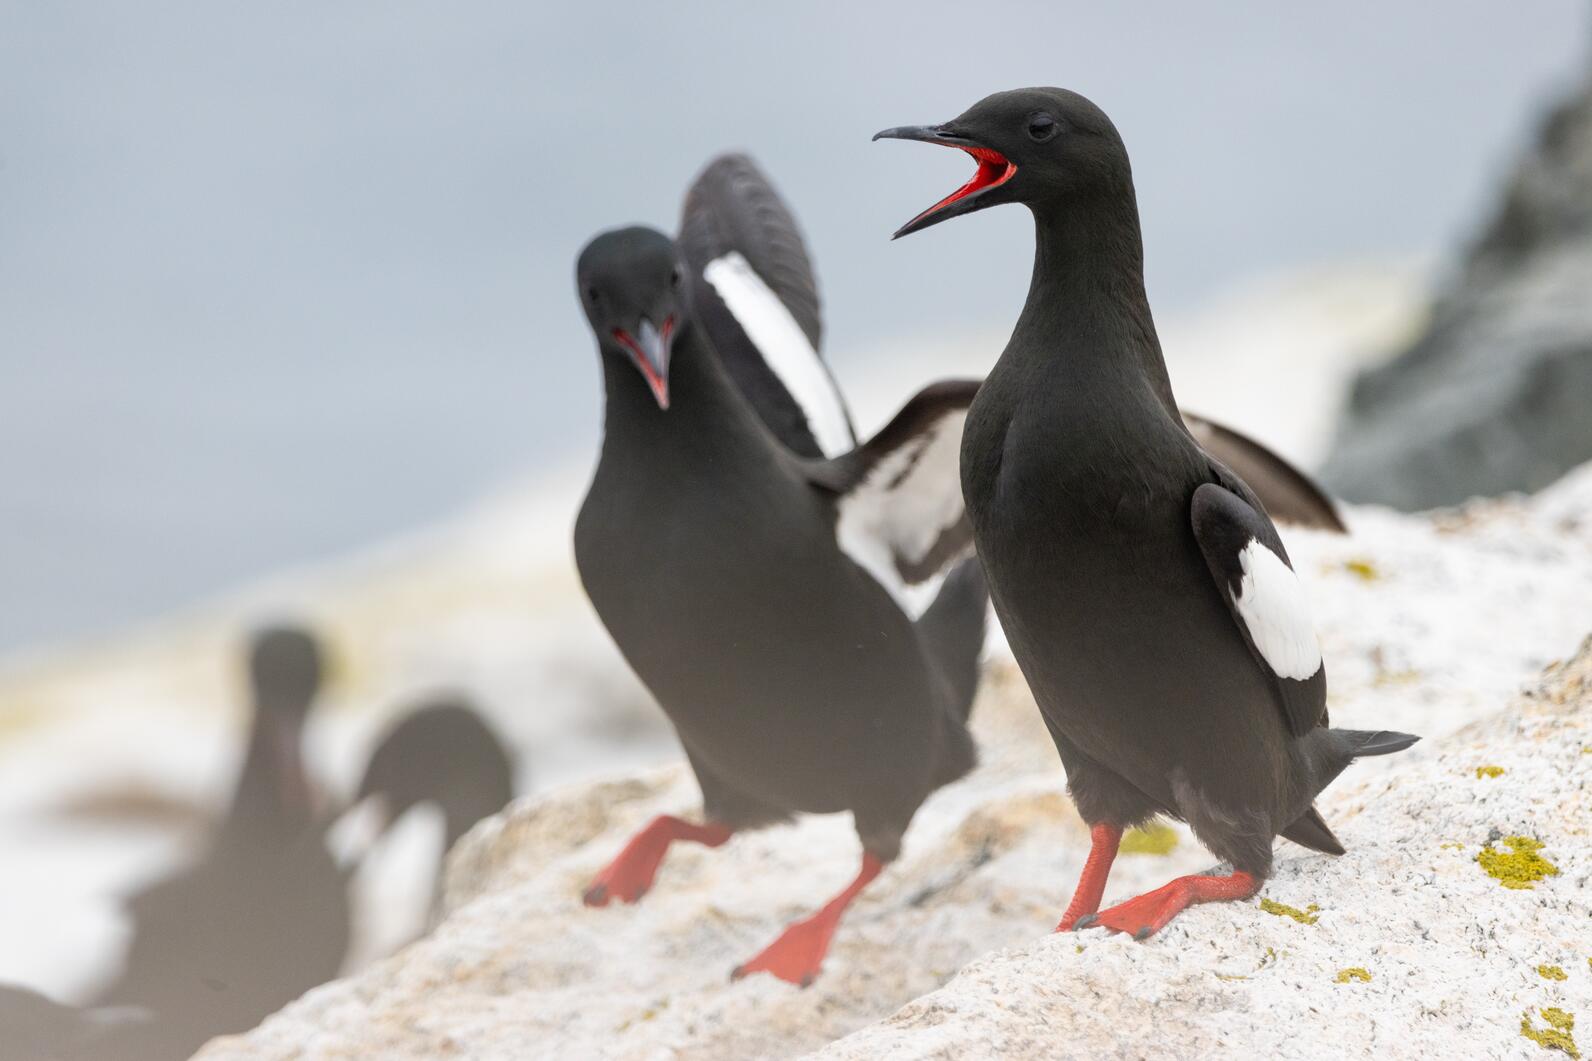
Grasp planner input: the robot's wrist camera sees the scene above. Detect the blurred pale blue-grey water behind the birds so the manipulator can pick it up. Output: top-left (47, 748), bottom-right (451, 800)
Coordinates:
top-left (0, 0), bottom-right (1587, 653)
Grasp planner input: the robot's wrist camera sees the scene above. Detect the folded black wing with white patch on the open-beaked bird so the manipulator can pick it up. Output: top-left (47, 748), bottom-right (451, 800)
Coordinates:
top-left (1189, 477), bottom-right (1326, 736)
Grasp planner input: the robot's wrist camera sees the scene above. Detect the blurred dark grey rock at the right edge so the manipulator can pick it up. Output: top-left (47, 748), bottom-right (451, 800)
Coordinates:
top-left (1321, 75), bottom-right (1592, 510)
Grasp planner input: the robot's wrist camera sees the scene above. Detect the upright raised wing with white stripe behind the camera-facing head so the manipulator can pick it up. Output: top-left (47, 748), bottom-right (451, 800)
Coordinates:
top-left (680, 155), bottom-right (856, 457)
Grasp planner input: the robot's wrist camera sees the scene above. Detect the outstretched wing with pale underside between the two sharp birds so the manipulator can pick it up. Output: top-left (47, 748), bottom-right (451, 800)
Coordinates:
top-left (809, 379), bottom-right (979, 585)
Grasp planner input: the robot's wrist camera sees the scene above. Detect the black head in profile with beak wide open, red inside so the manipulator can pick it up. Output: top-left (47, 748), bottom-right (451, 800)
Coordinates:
top-left (874, 88), bottom-right (1134, 239)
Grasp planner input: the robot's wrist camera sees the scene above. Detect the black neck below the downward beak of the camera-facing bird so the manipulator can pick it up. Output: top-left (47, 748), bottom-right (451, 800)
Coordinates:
top-left (602, 323), bottom-right (769, 460)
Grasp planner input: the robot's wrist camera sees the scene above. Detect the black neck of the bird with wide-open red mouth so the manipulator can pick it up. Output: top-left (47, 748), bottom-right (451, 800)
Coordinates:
top-left (1006, 186), bottom-right (1176, 411)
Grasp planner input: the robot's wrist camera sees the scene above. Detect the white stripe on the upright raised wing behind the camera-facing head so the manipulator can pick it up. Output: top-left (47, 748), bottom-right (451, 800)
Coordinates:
top-left (702, 250), bottom-right (856, 457)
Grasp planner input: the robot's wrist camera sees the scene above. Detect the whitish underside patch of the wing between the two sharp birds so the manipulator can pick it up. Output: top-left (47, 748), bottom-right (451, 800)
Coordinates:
top-left (834, 409), bottom-right (968, 618)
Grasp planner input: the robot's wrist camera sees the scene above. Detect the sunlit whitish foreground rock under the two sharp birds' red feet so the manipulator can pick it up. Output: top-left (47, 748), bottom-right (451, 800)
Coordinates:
top-left (201, 468), bottom-right (1592, 1059)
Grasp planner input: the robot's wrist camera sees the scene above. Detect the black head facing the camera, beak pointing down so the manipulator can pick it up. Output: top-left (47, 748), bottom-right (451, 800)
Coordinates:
top-left (575, 225), bottom-right (689, 409)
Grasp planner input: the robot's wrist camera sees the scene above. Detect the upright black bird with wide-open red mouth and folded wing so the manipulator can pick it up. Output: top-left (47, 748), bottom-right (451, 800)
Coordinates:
top-left (874, 88), bottom-right (1417, 937)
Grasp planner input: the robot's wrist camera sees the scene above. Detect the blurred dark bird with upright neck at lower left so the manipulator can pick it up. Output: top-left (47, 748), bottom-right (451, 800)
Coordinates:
top-left (97, 626), bottom-right (349, 1059)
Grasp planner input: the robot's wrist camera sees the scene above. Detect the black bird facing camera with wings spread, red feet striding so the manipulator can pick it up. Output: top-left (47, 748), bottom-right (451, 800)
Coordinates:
top-left (575, 155), bottom-right (987, 985)
